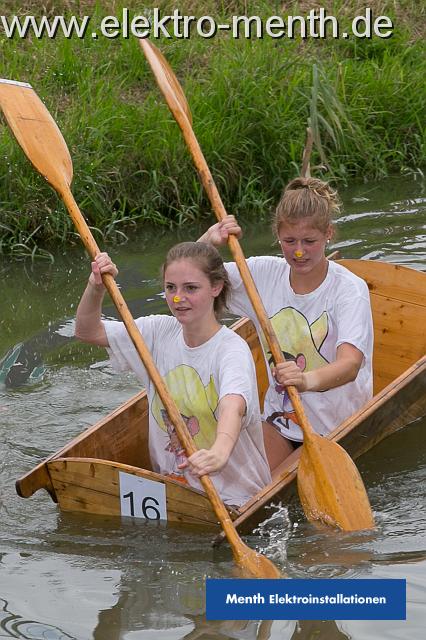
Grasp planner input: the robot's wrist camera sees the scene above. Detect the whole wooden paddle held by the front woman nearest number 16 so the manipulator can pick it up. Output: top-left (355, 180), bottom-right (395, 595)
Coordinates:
top-left (0, 80), bottom-right (281, 578)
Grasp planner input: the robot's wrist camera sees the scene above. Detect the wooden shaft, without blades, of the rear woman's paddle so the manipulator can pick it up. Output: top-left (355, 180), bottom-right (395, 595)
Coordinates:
top-left (169, 106), bottom-right (314, 438)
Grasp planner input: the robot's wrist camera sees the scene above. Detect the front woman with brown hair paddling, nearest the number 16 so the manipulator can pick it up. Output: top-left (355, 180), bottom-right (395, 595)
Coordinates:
top-left (75, 242), bottom-right (270, 506)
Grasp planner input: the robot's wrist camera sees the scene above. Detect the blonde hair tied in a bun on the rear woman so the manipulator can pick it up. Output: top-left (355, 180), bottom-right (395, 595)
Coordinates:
top-left (272, 178), bottom-right (341, 235)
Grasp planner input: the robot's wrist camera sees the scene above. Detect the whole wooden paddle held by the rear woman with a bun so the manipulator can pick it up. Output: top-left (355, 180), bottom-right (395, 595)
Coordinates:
top-left (139, 40), bottom-right (374, 531)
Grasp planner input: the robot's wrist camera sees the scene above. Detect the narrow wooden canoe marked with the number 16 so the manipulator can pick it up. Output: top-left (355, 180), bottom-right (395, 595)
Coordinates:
top-left (16, 260), bottom-right (426, 540)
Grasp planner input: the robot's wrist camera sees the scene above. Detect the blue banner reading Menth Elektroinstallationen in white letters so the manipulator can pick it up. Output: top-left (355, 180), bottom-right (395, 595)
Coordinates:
top-left (206, 578), bottom-right (406, 620)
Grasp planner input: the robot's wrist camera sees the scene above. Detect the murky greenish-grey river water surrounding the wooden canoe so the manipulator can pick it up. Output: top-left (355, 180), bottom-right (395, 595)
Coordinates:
top-left (0, 178), bottom-right (426, 640)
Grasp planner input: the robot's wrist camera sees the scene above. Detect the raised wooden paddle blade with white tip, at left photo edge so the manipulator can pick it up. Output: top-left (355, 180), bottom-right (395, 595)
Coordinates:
top-left (0, 79), bottom-right (73, 193)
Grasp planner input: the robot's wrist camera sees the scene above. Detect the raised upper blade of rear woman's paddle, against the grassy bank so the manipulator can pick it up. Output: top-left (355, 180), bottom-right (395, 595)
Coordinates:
top-left (139, 39), bottom-right (192, 126)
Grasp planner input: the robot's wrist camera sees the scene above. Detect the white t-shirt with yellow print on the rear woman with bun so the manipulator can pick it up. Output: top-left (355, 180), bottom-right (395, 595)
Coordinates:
top-left (225, 256), bottom-right (373, 442)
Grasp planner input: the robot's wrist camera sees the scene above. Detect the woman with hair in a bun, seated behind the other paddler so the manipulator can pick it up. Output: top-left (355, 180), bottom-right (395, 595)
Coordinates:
top-left (200, 178), bottom-right (373, 470)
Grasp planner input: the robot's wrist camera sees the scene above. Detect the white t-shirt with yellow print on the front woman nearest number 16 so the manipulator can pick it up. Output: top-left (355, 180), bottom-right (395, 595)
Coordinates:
top-left (103, 315), bottom-right (271, 506)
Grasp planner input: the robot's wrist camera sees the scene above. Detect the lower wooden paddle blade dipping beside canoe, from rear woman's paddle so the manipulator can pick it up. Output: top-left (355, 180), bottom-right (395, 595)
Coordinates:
top-left (297, 434), bottom-right (375, 531)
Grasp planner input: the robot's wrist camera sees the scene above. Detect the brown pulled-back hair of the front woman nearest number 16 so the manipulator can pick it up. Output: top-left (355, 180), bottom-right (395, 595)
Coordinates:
top-left (161, 242), bottom-right (231, 317)
